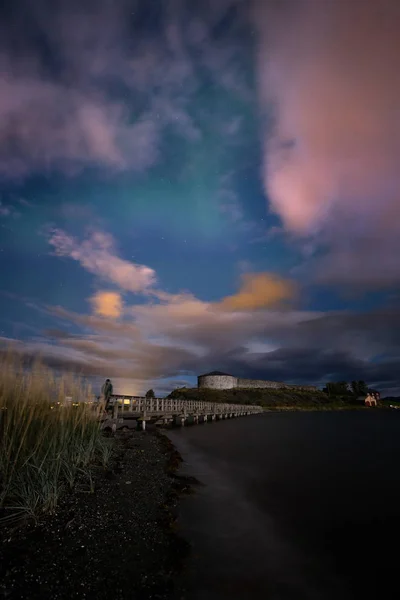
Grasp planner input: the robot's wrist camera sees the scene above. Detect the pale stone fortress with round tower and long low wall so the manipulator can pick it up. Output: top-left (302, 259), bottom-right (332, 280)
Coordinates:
top-left (197, 371), bottom-right (318, 391)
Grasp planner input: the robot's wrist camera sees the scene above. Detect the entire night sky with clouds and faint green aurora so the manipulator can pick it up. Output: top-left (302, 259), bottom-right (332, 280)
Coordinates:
top-left (0, 0), bottom-right (400, 395)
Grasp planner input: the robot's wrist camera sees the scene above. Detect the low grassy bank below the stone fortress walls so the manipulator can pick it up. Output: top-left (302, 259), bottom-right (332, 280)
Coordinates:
top-left (170, 388), bottom-right (363, 410)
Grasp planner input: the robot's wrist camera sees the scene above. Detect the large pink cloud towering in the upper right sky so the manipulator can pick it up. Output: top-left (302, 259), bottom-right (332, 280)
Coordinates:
top-left (255, 0), bottom-right (400, 281)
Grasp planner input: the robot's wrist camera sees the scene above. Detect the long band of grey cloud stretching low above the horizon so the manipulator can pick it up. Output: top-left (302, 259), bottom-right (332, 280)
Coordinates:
top-left (5, 296), bottom-right (400, 391)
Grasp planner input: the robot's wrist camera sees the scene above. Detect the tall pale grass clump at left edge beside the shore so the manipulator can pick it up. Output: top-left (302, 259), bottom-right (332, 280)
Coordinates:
top-left (0, 354), bottom-right (111, 519)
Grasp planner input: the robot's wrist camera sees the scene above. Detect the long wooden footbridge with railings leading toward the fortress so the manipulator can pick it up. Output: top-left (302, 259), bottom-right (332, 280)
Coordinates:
top-left (102, 395), bottom-right (263, 431)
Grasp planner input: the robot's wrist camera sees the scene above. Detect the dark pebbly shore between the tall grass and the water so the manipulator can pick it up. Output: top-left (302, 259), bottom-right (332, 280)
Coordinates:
top-left (0, 432), bottom-right (189, 600)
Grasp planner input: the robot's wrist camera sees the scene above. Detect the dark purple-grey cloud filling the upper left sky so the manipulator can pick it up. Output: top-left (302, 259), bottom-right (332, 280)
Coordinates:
top-left (0, 0), bottom-right (248, 177)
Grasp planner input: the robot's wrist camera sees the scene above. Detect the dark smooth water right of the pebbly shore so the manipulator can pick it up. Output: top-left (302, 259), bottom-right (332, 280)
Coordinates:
top-left (169, 411), bottom-right (400, 600)
